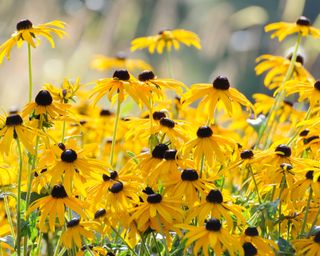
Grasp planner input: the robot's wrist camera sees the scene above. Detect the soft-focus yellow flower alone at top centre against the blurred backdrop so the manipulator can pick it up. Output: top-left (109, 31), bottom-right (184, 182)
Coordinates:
top-left (131, 29), bottom-right (201, 54)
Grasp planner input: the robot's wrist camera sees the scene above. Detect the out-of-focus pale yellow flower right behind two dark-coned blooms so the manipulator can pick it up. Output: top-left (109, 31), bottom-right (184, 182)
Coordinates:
top-left (91, 52), bottom-right (153, 71)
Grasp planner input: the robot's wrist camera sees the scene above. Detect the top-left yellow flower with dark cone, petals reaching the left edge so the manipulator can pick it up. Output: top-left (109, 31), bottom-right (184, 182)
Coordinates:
top-left (0, 20), bottom-right (66, 63)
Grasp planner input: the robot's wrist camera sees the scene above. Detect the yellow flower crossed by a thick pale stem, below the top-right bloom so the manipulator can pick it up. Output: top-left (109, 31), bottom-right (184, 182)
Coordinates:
top-left (255, 54), bottom-right (312, 90)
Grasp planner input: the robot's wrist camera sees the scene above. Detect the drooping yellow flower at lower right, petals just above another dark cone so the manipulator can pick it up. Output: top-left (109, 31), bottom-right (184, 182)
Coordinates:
top-left (186, 189), bottom-right (245, 228)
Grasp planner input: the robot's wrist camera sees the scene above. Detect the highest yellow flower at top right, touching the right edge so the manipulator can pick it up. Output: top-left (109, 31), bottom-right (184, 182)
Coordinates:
top-left (264, 16), bottom-right (320, 42)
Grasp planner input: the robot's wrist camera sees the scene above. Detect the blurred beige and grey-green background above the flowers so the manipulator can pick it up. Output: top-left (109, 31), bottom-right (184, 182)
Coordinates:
top-left (0, 0), bottom-right (320, 110)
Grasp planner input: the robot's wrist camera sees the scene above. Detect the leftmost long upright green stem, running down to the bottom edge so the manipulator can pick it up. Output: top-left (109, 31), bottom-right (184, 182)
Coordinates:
top-left (16, 137), bottom-right (23, 256)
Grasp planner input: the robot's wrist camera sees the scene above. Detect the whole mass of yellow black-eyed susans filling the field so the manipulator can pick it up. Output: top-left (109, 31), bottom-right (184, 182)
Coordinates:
top-left (0, 17), bottom-right (320, 256)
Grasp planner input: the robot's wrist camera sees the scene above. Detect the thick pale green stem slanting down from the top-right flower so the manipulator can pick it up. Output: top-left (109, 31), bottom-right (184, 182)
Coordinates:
top-left (255, 33), bottom-right (302, 148)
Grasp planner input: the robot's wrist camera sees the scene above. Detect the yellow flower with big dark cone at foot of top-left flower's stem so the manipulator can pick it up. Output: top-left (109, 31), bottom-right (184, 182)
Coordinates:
top-left (22, 90), bottom-right (70, 119)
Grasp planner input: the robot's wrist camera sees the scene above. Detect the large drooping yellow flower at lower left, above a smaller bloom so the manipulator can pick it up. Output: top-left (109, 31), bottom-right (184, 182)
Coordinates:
top-left (28, 184), bottom-right (85, 231)
